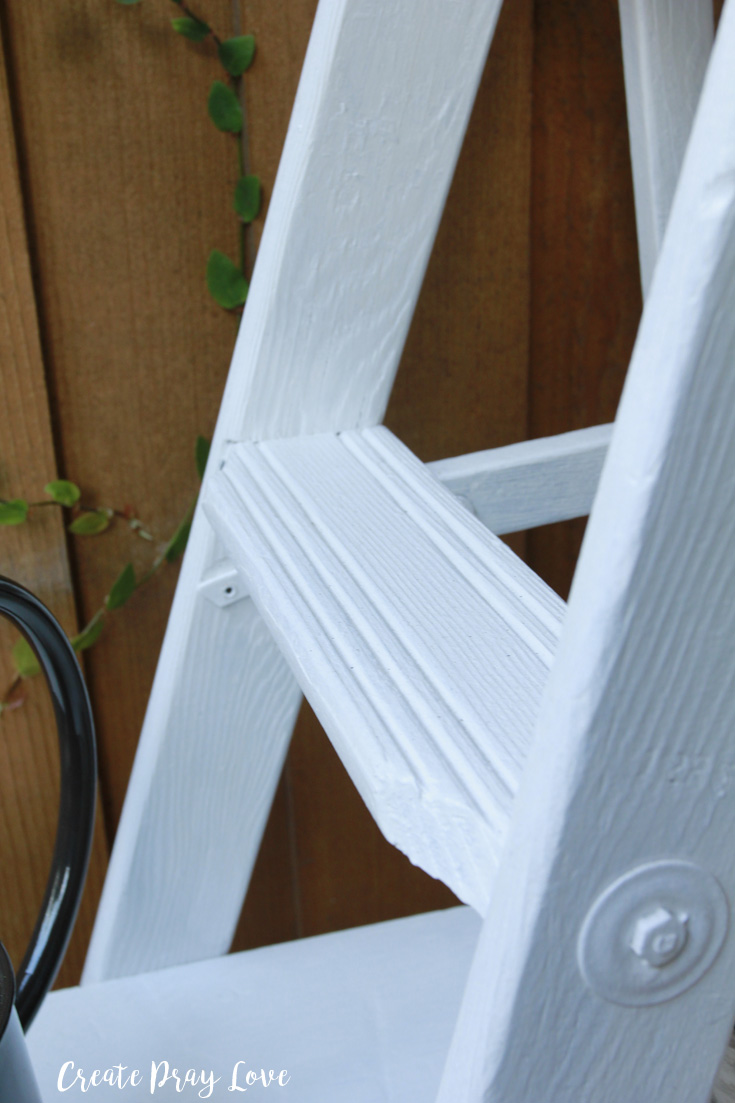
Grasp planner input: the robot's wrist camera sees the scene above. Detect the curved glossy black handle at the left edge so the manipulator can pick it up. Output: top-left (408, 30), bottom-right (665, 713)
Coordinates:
top-left (0, 577), bottom-right (97, 1029)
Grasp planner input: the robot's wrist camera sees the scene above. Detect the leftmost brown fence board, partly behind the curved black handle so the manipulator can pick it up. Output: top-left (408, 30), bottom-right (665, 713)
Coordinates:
top-left (0, 15), bottom-right (107, 984)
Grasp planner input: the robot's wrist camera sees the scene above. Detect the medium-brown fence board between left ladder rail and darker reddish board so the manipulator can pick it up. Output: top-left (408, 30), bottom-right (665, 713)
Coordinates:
top-left (385, 0), bottom-right (534, 462)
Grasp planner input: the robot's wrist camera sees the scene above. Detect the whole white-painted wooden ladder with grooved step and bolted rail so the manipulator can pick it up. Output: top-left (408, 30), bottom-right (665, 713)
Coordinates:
top-left (43, 0), bottom-right (735, 1103)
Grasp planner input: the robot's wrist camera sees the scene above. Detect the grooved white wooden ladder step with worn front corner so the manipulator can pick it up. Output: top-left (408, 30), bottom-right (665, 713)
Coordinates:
top-left (205, 427), bottom-right (565, 912)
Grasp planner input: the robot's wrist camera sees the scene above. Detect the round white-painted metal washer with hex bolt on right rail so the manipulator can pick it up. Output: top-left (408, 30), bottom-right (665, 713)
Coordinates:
top-left (577, 861), bottom-right (729, 1007)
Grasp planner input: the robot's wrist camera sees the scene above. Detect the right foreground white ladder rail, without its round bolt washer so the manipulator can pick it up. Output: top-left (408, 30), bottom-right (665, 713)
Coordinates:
top-left (439, 3), bottom-right (735, 1103)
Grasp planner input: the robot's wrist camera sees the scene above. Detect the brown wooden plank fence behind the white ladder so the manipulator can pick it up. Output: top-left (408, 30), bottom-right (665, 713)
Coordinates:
top-left (0, 0), bottom-right (653, 984)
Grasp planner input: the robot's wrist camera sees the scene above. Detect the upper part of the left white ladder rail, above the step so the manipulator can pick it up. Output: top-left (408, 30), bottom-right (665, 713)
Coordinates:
top-left (220, 0), bottom-right (500, 451)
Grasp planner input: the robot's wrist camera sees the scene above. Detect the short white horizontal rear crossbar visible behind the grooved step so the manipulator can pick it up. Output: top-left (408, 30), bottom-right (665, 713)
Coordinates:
top-left (426, 425), bottom-right (613, 535)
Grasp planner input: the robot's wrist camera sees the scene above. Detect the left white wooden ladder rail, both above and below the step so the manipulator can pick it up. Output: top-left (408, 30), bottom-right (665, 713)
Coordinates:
top-left (85, 0), bottom-right (501, 981)
